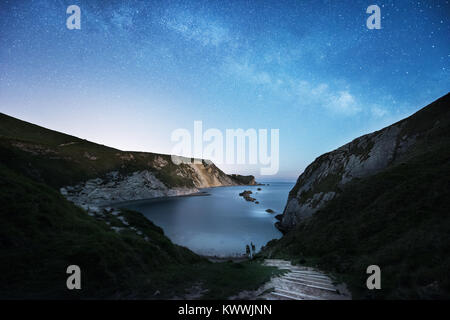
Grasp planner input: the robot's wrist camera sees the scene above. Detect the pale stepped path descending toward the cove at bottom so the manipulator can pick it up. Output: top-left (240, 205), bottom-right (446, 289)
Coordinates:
top-left (261, 259), bottom-right (351, 300)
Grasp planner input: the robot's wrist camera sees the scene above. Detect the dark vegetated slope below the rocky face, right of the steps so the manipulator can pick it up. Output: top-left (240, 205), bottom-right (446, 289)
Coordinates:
top-left (263, 96), bottom-right (450, 299)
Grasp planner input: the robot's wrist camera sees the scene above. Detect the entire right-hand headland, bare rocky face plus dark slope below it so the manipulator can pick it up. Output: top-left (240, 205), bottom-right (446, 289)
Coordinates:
top-left (261, 95), bottom-right (450, 299)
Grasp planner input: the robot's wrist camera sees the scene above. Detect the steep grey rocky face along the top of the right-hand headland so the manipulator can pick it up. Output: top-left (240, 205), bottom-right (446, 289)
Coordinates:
top-left (277, 94), bottom-right (450, 231)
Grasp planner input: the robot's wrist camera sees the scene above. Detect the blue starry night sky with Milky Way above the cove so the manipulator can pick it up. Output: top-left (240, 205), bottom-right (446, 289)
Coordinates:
top-left (0, 0), bottom-right (450, 181)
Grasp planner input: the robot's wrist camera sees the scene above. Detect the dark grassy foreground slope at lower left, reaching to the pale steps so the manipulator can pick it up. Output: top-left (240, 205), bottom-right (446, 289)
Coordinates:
top-left (0, 165), bottom-right (282, 299)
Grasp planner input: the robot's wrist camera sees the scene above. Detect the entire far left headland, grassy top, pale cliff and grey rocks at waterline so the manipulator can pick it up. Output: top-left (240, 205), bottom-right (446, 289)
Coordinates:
top-left (0, 114), bottom-right (254, 206)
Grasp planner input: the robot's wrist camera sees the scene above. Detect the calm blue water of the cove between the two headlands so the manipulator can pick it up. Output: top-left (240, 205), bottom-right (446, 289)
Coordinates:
top-left (116, 183), bottom-right (294, 256)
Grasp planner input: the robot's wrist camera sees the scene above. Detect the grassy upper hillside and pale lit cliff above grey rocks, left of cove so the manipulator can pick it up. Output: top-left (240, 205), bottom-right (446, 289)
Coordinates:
top-left (0, 113), bottom-right (253, 189)
